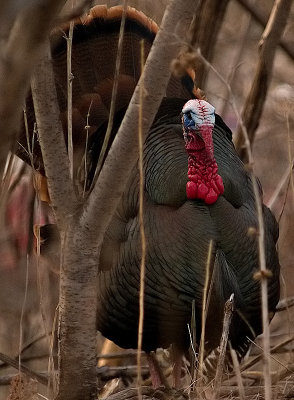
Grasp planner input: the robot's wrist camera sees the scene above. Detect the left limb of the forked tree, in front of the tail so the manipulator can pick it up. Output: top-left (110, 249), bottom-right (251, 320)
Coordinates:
top-left (32, 42), bottom-right (77, 222)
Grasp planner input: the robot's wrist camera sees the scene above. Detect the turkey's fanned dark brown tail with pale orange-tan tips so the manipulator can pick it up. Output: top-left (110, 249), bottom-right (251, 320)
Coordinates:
top-left (17, 6), bottom-right (194, 189)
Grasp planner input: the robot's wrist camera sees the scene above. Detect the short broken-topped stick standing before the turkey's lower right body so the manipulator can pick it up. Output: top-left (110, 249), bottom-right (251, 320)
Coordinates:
top-left (213, 294), bottom-right (234, 399)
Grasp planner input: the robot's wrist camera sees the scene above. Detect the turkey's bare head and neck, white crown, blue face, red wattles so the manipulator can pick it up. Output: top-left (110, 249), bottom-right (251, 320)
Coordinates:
top-left (182, 100), bottom-right (224, 204)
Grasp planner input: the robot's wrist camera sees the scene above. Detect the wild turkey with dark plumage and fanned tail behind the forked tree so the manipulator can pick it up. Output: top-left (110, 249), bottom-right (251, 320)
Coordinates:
top-left (18, 7), bottom-right (279, 388)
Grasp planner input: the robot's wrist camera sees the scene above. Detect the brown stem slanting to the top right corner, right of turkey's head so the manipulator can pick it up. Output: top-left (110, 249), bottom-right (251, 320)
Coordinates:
top-left (235, 0), bottom-right (292, 160)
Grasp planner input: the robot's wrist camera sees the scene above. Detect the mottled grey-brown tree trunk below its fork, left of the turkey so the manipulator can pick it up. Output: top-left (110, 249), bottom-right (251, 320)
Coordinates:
top-left (57, 223), bottom-right (97, 400)
